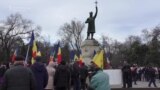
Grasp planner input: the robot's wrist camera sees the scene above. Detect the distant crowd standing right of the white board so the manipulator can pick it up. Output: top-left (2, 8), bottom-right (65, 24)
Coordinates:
top-left (122, 62), bottom-right (160, 88)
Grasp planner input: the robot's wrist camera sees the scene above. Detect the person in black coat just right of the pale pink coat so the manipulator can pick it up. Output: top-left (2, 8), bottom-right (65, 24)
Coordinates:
top-left (54, 60), bottom-right (70, 90)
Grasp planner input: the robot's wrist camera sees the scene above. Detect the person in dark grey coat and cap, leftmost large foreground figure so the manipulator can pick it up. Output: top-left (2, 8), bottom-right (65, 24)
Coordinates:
top-left (0, 56), bottom-right (36, 90)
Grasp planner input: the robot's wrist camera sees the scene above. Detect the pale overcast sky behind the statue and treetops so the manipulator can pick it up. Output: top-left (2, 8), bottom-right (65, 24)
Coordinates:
top-left (0, 0), bottom-right (160, 42)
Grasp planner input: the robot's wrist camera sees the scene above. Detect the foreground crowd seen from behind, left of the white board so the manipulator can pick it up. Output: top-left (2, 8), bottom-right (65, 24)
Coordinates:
top-left (0, 56), bottom-right (110, 90)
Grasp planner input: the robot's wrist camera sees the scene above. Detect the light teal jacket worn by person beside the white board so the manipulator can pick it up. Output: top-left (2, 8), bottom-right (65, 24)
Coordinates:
top-left (90, 70), bottom-right (111, 90)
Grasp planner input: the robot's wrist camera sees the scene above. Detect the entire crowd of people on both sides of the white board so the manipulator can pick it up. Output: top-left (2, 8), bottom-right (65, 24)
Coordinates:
top-left (0, 56), bottom-right (160, 90)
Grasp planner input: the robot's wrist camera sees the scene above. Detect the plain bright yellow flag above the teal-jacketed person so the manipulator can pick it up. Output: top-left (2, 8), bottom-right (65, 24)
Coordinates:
top-left (93, 50), bottom-right (104, 69)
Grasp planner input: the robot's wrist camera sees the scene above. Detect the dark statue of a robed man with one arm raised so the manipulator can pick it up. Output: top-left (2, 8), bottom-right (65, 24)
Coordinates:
top-left (85, 6), bottom-right (98, 39)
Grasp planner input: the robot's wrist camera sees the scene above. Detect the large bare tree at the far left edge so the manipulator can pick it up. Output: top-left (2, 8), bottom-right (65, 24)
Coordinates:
top-left (0, 13), bottom-right (40, 61)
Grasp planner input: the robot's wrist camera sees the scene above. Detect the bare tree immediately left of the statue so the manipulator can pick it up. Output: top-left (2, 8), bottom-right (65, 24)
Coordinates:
top-left (58, 20), bottom-right (84, 51)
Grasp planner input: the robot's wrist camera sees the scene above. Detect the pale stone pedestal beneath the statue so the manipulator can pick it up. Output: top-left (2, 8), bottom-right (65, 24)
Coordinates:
top-left (81, 39), bottom-right (100, 65)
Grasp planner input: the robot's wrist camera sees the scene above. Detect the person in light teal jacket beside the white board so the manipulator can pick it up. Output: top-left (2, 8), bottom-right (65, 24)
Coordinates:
top-left (89, 62), bottom-right (111, 90)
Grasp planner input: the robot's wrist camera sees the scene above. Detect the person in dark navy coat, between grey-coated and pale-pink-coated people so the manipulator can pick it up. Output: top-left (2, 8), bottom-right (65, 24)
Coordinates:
top-left (31, 56), bottom-right (48, 90)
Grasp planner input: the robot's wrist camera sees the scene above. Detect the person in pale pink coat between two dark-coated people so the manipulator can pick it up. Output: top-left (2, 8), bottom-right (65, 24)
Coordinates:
top-left (45, 61), bottom-right (55, 90)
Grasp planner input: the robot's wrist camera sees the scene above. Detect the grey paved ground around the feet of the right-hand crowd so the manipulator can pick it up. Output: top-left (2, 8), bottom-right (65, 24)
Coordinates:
top-left (111, 80), bottom-right (160, 88)
